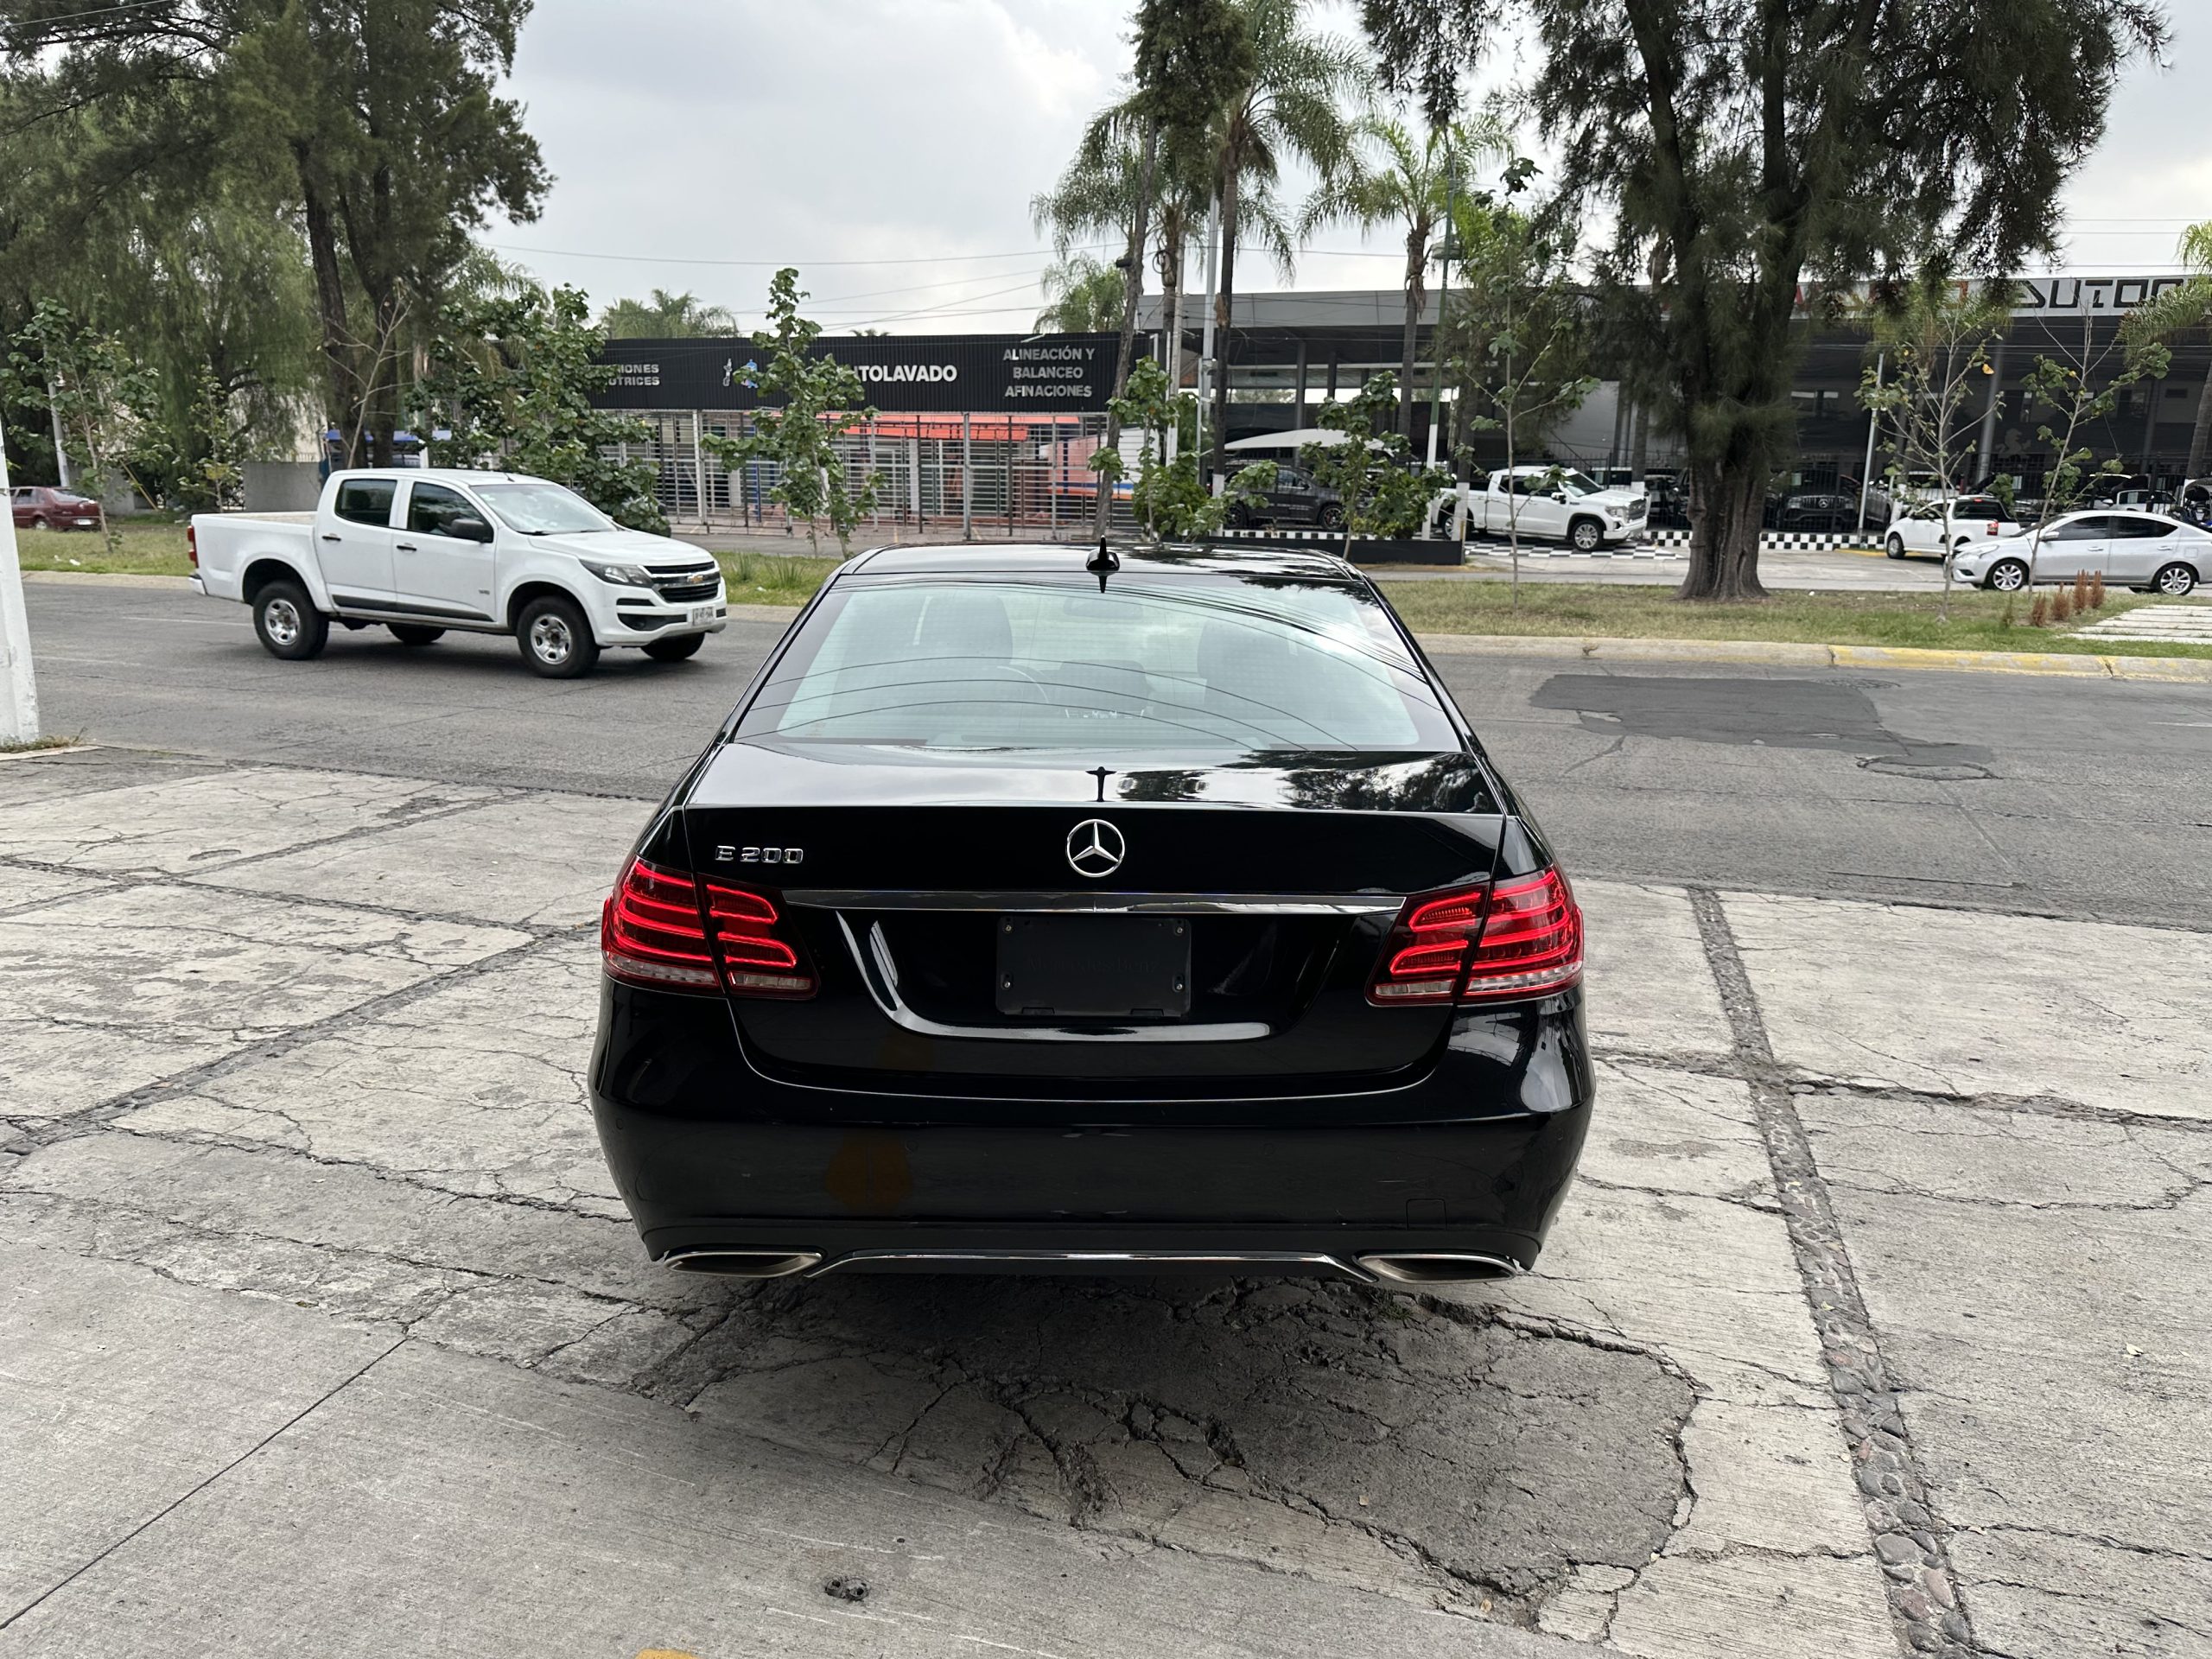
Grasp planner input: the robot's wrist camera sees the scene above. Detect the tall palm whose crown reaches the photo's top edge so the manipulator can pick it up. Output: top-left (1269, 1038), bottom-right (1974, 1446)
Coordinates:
top-left (1212, 0), bottom-right (1374, 471)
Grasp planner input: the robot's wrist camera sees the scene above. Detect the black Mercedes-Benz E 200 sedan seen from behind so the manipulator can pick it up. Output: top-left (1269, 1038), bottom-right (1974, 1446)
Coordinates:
top-left (591, 546), bottom-right (1592, 1283)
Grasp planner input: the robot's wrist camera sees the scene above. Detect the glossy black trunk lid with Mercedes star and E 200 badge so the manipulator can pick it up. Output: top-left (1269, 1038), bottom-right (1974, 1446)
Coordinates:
top-left (681, 741), bottom-right (1504, 1097)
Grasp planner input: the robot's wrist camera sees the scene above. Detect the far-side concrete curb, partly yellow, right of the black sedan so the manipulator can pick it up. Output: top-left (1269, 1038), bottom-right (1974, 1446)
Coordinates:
top-left (1415, 631), bottom-right (2212, 686)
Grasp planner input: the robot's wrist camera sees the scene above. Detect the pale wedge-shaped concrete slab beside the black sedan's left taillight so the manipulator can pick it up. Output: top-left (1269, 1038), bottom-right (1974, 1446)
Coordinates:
top-left (194, 794), bottom-right (652, 927)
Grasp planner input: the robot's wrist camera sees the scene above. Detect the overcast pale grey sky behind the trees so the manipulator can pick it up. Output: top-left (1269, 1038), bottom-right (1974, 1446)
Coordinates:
top-left (486, 0), bottom-right (2212, 334)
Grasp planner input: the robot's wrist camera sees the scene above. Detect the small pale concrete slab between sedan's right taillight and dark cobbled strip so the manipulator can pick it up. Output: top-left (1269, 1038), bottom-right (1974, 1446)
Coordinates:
top-left (1575, 880), bottom-right (1730, 1058)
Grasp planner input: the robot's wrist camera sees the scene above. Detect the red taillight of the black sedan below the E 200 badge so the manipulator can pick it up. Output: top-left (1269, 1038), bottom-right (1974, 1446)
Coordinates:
top-left (600, 858), bottom-right (814, 998)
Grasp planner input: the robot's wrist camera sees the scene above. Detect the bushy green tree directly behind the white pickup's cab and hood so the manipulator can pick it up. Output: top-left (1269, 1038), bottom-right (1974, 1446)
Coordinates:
top-left (420, 283), bottom-right (668, 533)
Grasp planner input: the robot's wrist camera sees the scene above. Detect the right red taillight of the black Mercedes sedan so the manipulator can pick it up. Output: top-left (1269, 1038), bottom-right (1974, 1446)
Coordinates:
top-left (1367, 869), bottom-right (1581, 1007)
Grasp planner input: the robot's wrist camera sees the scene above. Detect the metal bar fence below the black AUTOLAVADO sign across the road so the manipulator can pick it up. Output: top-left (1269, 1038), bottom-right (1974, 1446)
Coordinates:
top-left (617, 410), bottom-right (1135, 540)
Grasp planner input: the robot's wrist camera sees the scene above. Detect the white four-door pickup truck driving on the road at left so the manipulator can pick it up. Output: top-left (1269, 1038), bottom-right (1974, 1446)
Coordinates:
top-left (190, 467), bottom-right (728, 679)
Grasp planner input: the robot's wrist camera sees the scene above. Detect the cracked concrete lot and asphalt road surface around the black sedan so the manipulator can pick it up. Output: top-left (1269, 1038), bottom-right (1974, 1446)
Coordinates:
top-left (0, 582), bottom-right (2212, 1659)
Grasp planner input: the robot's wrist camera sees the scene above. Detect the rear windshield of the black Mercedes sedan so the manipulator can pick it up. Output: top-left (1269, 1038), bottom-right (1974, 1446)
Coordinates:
top-left (736, 573), bottom-right (1460, 757)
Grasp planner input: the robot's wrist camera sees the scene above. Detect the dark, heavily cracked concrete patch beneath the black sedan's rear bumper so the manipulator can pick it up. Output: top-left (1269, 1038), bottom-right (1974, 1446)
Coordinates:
top-left (675, 1279), bottom-right (1690, 1612)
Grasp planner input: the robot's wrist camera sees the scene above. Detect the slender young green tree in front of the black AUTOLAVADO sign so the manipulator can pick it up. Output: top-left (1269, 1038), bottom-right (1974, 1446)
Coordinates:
top-left (702, 268), bottom-right (880, 553)
